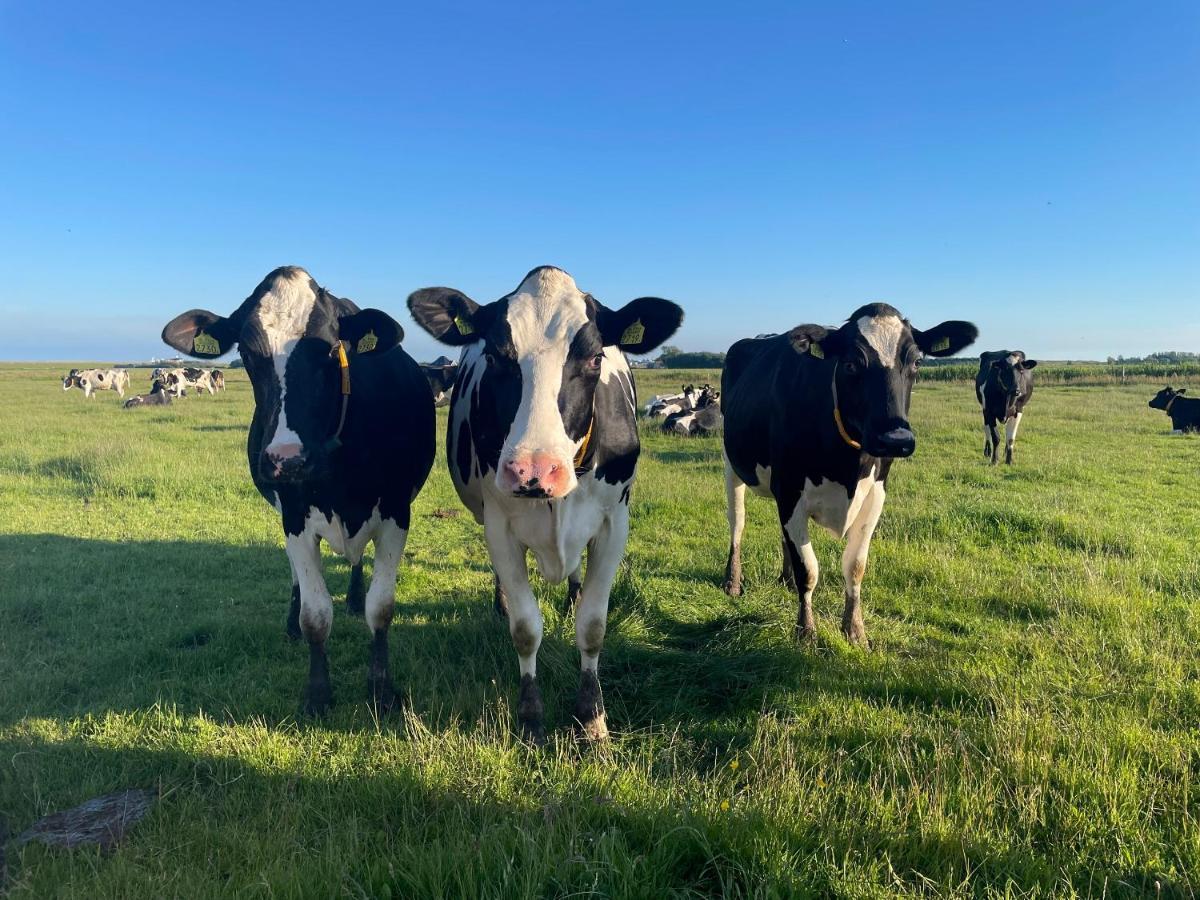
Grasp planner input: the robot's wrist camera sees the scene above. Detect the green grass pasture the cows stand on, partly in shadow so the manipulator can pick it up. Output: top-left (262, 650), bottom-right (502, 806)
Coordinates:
top-left (0, 365), bottom-right (1200, 898)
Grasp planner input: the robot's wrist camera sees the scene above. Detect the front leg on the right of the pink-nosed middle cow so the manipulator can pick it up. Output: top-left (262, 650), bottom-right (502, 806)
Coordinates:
top-left (575, 504), bottom-right (629, 740)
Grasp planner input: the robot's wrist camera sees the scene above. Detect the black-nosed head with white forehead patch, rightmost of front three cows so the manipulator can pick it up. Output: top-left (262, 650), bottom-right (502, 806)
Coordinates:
top-left (788, 304), bottom-right (979, 457)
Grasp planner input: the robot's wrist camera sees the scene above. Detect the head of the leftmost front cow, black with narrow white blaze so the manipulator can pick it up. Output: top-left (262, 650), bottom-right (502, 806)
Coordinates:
top-left (162, 266), bottom-right (404, 482)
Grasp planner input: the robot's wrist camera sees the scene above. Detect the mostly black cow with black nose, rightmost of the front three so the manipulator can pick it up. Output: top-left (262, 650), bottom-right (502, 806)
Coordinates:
top-left (721, 304), bottom-right (978, 644)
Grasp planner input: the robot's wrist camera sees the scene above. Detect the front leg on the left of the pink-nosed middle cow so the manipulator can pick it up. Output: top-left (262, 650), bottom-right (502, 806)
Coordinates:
top-left (484, 506), bottom-right (546, 746)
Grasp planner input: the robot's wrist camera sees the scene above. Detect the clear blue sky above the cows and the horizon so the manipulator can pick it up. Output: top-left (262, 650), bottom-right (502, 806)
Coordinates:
top-left (0, 0), bottom-right (1200, 360)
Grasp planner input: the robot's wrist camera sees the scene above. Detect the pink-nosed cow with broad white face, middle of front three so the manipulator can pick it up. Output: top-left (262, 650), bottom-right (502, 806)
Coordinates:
top-left (408, 266), bottom-right (683, 743)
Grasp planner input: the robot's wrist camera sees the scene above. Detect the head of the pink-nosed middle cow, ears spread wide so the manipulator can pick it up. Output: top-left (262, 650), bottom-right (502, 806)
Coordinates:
top-left (408, 266), bottom-right (683, 498)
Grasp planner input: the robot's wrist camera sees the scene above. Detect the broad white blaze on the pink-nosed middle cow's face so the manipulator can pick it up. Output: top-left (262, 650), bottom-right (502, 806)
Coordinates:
top-left (500, 269), bottom-right (588, 472)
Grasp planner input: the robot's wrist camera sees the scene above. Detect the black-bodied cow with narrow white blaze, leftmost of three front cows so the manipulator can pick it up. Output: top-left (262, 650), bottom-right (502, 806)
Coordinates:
top-left (162, 266), bottom-right (434, 713)
